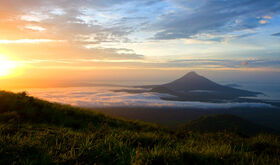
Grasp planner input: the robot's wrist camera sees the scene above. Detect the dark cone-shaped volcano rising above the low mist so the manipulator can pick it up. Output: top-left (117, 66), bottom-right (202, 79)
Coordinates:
top-left (151, 72), bottom-right (261, 101)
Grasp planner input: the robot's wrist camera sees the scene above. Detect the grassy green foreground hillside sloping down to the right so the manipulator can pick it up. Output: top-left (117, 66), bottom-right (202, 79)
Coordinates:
top-left (0, 92), bottom-right (280, 165)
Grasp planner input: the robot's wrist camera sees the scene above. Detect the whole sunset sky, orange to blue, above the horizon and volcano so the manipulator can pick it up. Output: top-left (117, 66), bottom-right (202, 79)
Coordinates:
top-left (0, 0), bottom-right (280, 89)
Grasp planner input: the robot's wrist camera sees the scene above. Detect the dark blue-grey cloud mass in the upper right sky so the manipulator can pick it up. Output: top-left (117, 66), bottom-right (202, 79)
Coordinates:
top-left (155, 0), bottom-right (280, 39)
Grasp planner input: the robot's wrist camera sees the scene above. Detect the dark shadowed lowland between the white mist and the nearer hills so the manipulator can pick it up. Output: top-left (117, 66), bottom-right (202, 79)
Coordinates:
top-left (93, 107), bottom-right (280, 132)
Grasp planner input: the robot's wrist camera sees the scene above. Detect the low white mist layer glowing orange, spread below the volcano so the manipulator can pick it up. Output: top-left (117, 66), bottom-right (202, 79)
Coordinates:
top-left (14, 87), bottom-right (271, 109)
